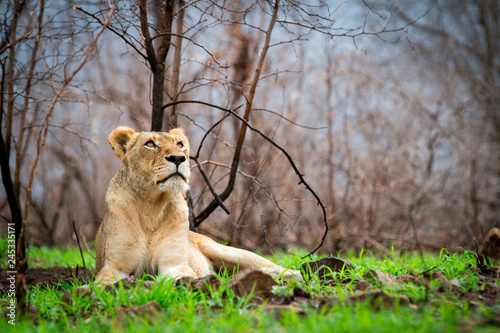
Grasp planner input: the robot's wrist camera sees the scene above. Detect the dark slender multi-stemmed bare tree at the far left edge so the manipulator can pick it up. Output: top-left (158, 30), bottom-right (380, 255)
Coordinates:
top-left (0, 0), bottom-right (114, 312)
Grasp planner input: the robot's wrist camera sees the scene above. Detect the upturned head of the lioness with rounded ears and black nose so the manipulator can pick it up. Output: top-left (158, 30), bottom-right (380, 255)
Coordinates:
top-left (109, 127), bottom-right (191, 193)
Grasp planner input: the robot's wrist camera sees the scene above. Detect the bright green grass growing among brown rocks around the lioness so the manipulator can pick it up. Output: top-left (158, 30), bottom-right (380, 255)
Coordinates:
top-left (0, 243), bottom-right (500, 333)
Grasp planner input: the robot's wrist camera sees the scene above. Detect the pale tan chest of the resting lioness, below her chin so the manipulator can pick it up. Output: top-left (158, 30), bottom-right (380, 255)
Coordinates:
top-left (103, 192), bottom-right (189, 275)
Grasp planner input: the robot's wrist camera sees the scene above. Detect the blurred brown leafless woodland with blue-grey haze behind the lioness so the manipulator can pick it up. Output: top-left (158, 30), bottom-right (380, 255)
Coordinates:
top-left (0, 0), bottom-right (500, 253)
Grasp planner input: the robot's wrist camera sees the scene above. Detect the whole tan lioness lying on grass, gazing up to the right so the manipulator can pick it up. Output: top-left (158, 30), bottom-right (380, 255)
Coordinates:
top-left (96, 127), bottom-right (301, 284)
